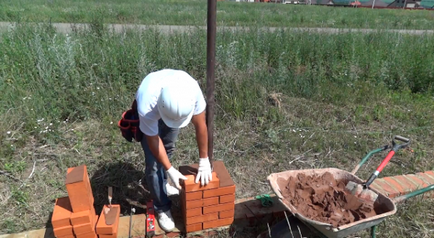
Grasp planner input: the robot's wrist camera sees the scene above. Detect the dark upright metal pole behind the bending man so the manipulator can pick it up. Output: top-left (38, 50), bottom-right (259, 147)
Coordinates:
top-left (206, 0), bottom-right (216, 167)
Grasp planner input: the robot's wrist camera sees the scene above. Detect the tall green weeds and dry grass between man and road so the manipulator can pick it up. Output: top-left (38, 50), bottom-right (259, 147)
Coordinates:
top-left (0, 21), bottom-right (434, 237)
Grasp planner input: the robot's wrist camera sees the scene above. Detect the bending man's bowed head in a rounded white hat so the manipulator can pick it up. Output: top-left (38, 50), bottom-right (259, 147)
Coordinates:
top-left (157, 85), bottom-right (195, 128)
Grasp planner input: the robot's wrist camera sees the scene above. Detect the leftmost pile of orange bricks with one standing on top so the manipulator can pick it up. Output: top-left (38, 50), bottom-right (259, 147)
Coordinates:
top-left (51, 165), bottom-right (98, 238)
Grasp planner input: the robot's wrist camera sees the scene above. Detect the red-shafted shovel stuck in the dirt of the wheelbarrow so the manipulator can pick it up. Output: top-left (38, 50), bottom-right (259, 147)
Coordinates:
top-left (346, 136), bottom-right (410, 202)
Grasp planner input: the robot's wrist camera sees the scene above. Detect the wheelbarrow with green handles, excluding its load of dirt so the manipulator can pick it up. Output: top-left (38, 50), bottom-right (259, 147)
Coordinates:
top-left (267, 136), bottom-right (434, 238)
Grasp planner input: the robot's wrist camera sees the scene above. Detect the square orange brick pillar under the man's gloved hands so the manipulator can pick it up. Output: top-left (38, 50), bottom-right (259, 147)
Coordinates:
top-left (179, 161), bottom-right (235, 233)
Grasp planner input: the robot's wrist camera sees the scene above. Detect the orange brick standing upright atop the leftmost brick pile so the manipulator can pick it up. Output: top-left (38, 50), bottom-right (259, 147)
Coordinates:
top-left (65, 165), bottom-right (94, 212)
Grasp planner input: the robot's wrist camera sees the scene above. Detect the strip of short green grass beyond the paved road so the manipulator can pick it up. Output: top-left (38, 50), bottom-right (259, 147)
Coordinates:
top-left (0, 0), bottom-right (434, 29)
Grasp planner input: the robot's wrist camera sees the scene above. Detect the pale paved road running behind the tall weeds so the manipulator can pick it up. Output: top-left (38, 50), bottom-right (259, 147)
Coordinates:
top-left (0, 22), bottom-right (434, 35)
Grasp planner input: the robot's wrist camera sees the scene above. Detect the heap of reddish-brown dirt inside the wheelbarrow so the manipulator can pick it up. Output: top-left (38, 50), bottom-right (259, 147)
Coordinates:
top-left (277, 172), bottom-right (377, 227)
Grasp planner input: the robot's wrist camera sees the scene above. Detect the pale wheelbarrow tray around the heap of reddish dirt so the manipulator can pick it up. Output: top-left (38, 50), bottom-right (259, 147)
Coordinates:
top-left (267, 168), bottom-right (397, 238)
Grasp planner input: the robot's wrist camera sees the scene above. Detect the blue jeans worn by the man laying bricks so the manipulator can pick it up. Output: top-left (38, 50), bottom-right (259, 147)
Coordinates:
top-left (141, 119), bottom-right (179, 212)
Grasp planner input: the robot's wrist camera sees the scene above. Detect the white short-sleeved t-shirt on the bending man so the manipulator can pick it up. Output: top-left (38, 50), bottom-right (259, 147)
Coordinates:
top-left (136, 69), bottom-right (206, 136)
